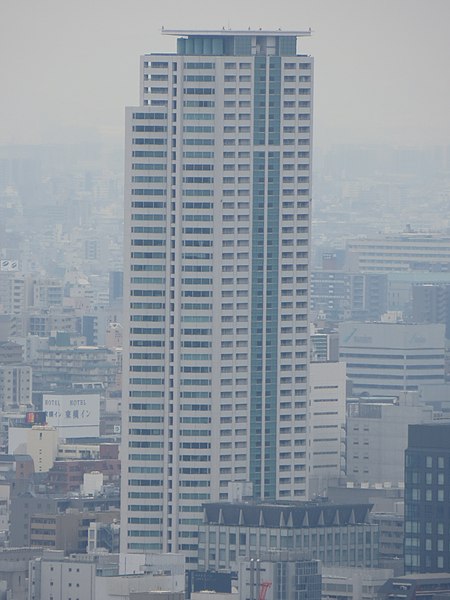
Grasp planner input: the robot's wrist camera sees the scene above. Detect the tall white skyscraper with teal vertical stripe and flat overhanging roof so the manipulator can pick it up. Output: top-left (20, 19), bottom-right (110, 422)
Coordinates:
top-left (122, 30), bottom-right (313, 562)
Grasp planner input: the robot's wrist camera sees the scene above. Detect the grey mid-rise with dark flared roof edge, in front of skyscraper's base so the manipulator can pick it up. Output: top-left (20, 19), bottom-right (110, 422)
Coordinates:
top-left (198, 502), bottom-right (378, 571)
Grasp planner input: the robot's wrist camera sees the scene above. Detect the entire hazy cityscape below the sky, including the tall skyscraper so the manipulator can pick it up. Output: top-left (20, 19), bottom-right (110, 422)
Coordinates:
top-left (0, 8), bottom-right (450, 600)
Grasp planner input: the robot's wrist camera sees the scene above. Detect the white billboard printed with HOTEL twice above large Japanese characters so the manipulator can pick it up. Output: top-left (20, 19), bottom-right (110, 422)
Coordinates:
top-left (42, 393), bottom-right (100, 438)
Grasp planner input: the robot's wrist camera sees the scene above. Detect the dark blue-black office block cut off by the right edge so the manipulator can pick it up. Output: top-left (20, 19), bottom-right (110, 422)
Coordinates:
top-left (405, 421), bottom-right (450, 573)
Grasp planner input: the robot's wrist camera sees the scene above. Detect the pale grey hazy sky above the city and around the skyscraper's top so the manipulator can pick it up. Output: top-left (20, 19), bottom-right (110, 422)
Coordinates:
top-left (0, 0), bottom-right (450, 145)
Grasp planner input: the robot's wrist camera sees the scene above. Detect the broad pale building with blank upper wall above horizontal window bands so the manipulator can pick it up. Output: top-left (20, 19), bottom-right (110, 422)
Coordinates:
top-left (339, 321), bottom-right (445, 396)
